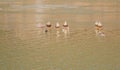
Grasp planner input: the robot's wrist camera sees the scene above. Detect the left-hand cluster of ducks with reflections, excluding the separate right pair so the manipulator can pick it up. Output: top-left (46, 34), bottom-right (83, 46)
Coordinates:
top-left (37, 21), bottom-right (69, 37)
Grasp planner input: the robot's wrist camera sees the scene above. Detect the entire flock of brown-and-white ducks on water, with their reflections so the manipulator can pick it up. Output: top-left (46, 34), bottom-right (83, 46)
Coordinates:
top-left (37, 21), bottom-right (105, 37)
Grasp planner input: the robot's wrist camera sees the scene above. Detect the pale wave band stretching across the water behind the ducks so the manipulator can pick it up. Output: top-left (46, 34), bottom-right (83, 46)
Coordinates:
top-left (0, 4), bottom-right (120, 13)
